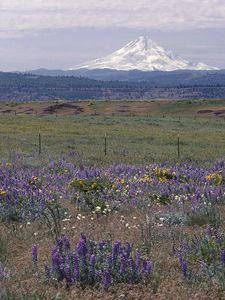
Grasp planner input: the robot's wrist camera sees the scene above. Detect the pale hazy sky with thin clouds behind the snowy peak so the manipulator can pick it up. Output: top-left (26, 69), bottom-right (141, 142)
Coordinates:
top-left (0, 0), bottom-right (225, 71)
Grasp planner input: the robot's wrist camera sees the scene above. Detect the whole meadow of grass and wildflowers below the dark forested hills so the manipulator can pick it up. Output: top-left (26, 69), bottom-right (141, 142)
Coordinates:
top-left (0, 99), bottom-right (225, 300)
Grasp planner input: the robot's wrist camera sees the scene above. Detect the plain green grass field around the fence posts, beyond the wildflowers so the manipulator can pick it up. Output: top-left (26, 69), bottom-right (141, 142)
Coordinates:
top-left (0, 100), bottom-right (225, 165)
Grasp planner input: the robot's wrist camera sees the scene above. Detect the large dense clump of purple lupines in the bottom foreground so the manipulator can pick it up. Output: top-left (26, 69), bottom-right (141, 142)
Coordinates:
top-left (32, 234), bottom-right (152, 288)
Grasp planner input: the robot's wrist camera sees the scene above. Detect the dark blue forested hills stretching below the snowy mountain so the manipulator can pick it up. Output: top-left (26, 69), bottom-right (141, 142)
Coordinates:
top-left (0, 70), bottom-right (225, 101)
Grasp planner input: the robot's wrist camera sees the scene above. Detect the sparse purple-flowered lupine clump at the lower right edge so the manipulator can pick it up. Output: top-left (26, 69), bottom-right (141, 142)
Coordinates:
top-left (175, 227), bottom-right (225, 287)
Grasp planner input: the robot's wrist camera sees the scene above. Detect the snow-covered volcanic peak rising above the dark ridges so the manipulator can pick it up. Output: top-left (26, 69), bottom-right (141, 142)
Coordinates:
top-left (70, 36), bottom-right (218, 71)
